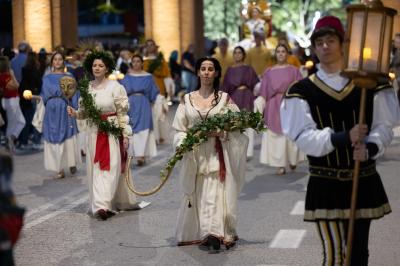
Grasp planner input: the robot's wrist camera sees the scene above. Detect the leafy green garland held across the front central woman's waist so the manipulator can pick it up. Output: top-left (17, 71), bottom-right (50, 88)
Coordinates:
top-left (160, 111), bottom-right (265, 179)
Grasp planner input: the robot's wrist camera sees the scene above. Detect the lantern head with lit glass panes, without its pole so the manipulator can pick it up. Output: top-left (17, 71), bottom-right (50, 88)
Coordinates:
top-left (343, 0), bottom-right (397, 82)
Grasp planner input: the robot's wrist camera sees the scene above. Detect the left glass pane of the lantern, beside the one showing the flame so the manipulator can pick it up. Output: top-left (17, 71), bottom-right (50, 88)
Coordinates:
top-left (347, 12), bottom-right (364, 70)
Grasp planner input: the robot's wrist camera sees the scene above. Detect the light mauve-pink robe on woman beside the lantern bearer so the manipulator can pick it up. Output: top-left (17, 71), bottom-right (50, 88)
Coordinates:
top-left (260, 65), bottom-right (303, 134)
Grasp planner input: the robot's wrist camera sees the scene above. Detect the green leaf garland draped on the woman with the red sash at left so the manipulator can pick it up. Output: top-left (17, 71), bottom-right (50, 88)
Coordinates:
top-left (78, 76), bottom-right (122, 139)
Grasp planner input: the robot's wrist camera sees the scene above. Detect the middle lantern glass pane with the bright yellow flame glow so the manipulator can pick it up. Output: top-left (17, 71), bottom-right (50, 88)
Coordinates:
top-left (362, 12), bottom-right (383, 72)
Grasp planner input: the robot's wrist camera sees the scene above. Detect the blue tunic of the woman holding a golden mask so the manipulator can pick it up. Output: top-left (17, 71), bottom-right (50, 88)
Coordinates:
top-left (40, 73), bottom-right (79, 144)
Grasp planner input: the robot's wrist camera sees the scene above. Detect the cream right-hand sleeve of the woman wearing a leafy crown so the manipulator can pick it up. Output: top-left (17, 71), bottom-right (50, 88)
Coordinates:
top-left (114, 82), bottom-right (132, 137)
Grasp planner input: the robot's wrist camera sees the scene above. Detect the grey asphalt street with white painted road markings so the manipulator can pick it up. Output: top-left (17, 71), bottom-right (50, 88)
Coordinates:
top-left (13, 109), bottom-right (400, 266)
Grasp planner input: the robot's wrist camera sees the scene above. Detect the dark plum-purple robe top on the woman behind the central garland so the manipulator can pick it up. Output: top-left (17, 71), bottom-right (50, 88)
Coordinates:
top-left (221, 65), bottom-right (259, 112)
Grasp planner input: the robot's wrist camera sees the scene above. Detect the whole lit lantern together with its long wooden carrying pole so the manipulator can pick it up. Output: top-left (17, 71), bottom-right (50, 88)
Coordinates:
top-left (342, 0), bottom-right (397, 266)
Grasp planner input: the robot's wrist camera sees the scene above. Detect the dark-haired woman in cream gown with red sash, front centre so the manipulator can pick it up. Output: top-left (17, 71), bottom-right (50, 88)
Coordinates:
top-left (172, 58), bottom-right (248, 250)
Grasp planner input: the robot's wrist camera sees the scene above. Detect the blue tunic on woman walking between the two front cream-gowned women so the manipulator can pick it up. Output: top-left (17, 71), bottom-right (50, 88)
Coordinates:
top-left (121, 74), bottom-right (159, 133)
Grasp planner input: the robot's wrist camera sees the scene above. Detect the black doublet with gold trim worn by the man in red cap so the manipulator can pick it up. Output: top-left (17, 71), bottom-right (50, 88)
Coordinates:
top-left (285, 75), bottom-right (391, 221)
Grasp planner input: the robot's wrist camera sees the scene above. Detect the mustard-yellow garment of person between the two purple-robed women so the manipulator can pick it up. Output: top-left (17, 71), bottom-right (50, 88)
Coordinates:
top-left (246, 46), bottom-right (273, 76)
